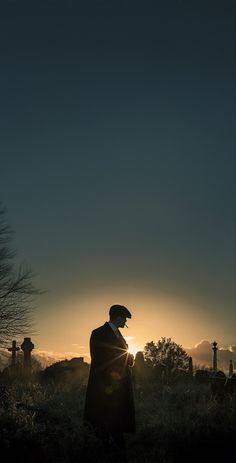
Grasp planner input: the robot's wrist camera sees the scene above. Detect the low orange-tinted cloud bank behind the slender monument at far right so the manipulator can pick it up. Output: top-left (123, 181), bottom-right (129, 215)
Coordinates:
top-left (185, 340), bottom-right (236, 372)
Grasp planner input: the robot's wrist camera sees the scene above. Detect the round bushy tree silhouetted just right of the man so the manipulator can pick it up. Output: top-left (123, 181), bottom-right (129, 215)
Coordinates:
top-left (144, 337), bottom-right (189, 373)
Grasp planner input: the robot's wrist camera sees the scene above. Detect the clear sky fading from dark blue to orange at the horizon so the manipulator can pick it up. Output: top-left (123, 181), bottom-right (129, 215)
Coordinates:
top-left (0, 0), bottom-right (236, 357)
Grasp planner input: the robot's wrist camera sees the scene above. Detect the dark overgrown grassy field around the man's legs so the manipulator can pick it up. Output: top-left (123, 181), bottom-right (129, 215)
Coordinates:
top-left (0, 381), bottom-right (236, 463)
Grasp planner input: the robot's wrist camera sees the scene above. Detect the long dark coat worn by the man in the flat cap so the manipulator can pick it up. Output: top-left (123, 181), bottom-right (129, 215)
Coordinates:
top-left (84, 322), bottom-right (135, 433)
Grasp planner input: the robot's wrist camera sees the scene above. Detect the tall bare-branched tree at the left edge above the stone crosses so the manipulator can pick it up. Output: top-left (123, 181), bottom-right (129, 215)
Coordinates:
top-left (0, 203), bottom-right (42, 346)
